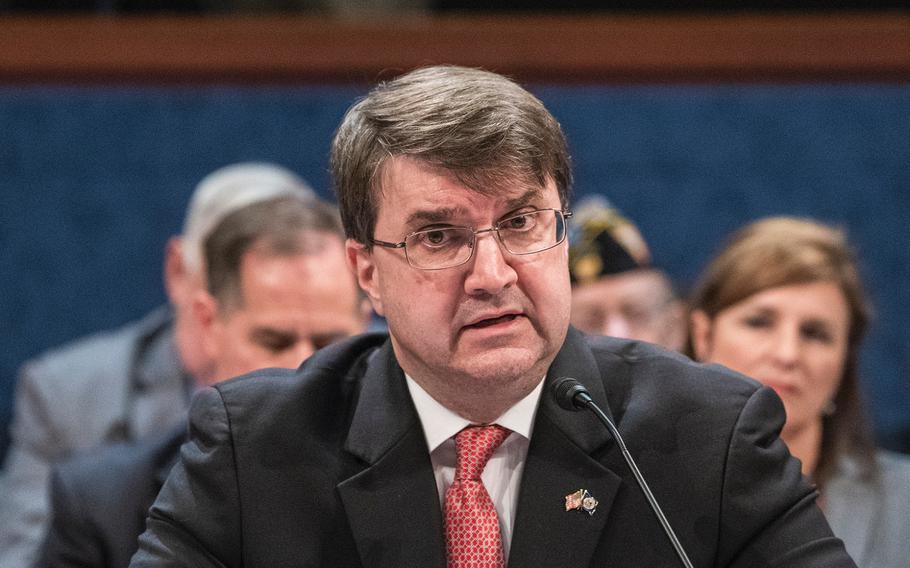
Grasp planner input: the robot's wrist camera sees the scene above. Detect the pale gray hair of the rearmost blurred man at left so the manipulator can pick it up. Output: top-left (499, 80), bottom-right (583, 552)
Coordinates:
top-left (183, 162), bottom-right (315, 273)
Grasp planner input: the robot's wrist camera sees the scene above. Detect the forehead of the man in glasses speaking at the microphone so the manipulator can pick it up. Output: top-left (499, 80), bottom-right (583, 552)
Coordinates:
top-left (377, 156), bottom-right (560, 224)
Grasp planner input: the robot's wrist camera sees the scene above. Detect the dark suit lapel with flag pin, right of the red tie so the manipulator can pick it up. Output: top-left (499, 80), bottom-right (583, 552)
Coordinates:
top-left (509, 329), bottom-right (622, 566)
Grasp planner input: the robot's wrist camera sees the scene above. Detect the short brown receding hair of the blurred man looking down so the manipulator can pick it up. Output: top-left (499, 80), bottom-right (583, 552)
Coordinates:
top-left (205, 196), bottom-right (344, 311)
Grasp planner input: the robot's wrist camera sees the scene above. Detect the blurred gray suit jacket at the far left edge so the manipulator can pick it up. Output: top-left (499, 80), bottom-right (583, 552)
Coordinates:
top-left (0, 309), bottom-right (189, 568)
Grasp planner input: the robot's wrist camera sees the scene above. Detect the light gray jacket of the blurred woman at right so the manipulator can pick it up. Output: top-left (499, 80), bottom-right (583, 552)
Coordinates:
top-left (825, 451), bottom-right (910, 568)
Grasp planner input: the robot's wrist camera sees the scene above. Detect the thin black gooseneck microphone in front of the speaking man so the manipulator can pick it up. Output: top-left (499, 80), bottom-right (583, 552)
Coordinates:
top-left (552, 377), bottom-right (692, 568)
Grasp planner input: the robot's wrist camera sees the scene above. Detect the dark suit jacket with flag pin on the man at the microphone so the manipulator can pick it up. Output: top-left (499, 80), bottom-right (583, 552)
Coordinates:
top-left (131, 330), bottom-right (854, 568)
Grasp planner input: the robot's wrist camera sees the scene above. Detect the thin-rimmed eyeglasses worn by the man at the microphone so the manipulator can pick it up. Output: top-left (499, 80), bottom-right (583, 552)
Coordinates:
top-left (370, 209), bottom-right (572, 270)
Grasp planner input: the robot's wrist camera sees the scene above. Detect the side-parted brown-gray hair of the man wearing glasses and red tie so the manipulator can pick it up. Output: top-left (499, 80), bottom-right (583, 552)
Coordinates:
top-left (331, 66), bottom-right (572, 247)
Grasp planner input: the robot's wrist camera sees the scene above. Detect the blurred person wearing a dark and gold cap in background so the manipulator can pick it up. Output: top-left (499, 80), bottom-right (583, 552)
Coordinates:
top-left (569, 199), bottom-right (686, 351)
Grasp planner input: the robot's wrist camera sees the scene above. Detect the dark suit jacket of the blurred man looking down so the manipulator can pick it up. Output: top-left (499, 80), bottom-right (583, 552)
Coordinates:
top-left (37, 424), bottom-right (186, 568)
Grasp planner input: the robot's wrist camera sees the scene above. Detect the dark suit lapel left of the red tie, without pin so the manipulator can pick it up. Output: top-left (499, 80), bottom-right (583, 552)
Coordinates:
top-left (338, 342), bottom-right (445, 568)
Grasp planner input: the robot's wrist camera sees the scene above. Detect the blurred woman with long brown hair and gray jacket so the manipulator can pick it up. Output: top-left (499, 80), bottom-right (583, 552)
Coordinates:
top-left (690, 217), bottom-right (910, 568)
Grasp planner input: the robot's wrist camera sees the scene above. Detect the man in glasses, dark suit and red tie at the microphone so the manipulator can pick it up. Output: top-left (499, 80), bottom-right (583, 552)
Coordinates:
top-left (131, 67), bottom-right (854, 568)
